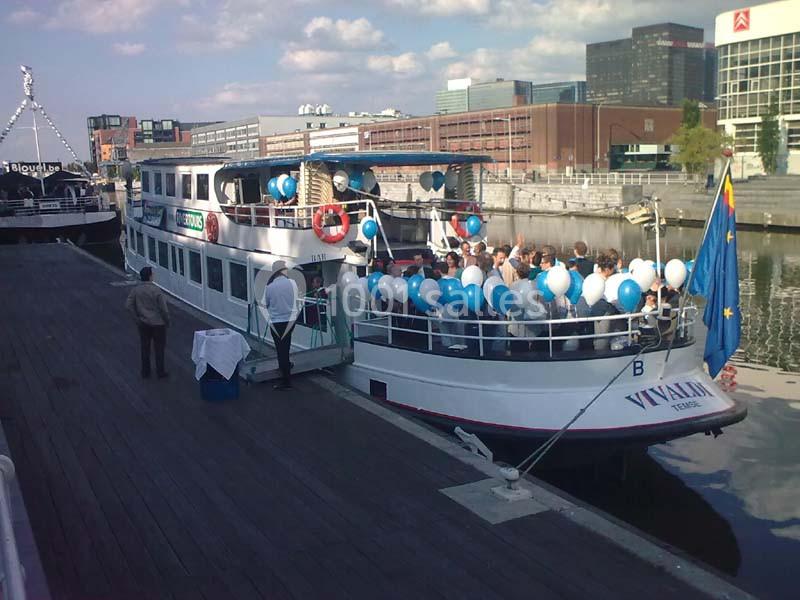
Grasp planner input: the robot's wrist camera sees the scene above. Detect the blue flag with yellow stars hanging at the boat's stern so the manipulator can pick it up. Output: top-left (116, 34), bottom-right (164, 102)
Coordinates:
top-left (689, 162), bottom-right (741, 377)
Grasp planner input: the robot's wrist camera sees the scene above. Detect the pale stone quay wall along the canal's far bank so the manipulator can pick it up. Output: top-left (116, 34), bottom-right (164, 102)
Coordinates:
top-left (381, 177), bottom-right (800, 230)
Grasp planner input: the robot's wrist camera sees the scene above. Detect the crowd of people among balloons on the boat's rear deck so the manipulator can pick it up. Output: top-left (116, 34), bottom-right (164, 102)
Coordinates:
top-left (366, 235), bottom-right (681, 351)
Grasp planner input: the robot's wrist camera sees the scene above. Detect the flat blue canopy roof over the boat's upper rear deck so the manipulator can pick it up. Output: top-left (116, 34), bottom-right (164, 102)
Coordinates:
top-left (222, 151), bottom-right (494, 170)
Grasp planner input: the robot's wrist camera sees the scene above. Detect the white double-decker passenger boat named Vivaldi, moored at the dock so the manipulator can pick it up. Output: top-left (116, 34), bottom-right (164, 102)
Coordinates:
top-left (125, 152), bottom-right (746, 462)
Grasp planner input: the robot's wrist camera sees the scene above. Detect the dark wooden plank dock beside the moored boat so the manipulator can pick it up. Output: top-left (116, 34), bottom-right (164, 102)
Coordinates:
top-left (0, 245), bottom-right (752, 600)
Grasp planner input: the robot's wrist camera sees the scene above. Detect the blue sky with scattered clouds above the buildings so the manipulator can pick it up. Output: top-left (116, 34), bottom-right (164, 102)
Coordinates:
top-left (0, 0), bottom-right (747, 163)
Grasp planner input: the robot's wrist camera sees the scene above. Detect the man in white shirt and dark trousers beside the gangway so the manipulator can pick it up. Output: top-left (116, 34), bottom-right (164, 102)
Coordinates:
top-left (264, 260), bottom-right (297, 390)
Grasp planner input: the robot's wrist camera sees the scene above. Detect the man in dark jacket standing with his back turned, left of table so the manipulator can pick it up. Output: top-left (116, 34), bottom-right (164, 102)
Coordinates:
top-left (125, 267), bottom-right (169, 378)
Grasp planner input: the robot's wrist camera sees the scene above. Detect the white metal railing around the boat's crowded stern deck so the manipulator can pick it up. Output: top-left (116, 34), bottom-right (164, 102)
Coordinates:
top-left (353, 306), bottom-right (697, 359)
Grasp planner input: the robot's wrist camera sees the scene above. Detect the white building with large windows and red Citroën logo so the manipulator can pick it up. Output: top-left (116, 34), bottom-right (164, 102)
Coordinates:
top-left (716, 0), bottom-right (800, 177)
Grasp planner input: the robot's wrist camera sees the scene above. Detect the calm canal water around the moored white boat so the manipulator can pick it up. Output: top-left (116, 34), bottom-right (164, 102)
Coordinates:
top-left (89, 216), bottom-right (800, 598)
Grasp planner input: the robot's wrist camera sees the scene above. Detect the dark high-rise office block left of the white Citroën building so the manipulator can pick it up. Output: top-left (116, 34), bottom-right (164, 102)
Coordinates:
top-left (586, 23), bottom-right (714, 105)
